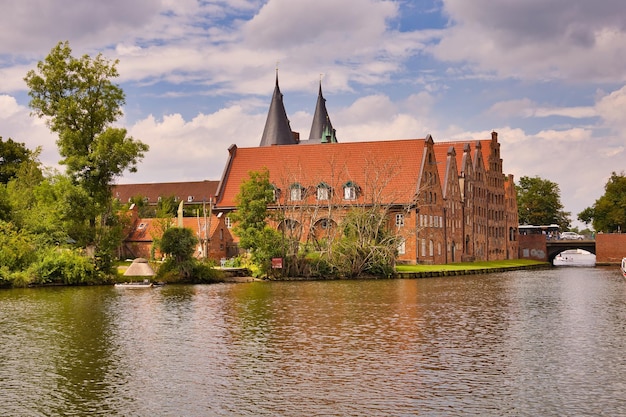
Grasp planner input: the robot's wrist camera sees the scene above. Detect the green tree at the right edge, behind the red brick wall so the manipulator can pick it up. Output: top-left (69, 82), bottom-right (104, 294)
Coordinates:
top-left (578, 171), bottom-right (626, 232)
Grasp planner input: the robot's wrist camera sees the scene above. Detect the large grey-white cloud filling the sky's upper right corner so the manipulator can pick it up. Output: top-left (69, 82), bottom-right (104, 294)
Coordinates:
top-left (432, 0), bottom-right (626, 82)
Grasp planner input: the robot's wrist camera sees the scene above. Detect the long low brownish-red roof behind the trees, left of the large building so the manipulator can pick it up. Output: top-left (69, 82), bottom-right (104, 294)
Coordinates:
top-left (113, 181), bottom-right (219, 203)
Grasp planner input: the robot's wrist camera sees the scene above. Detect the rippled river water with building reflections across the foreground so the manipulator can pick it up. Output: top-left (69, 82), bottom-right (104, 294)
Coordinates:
top-left (0, 268), bottom-right (626, 417)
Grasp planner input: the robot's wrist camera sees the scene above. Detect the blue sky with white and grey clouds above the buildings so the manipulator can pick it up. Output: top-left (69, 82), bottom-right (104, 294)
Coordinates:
top-left (0, 0), bottom-right (626, 226)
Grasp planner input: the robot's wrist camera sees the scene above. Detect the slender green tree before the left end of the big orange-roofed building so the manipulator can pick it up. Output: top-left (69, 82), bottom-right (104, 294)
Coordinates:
top-left (231, 169), bottom-right (284, 274)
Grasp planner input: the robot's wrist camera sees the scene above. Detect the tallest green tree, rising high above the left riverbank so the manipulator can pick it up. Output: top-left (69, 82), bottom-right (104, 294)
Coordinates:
top-left (24, 42), bottom-right (148, 246)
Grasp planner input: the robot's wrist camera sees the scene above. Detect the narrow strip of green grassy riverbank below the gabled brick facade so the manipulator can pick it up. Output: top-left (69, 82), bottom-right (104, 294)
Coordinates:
top-left (396, 259), bottom-right (550, 278)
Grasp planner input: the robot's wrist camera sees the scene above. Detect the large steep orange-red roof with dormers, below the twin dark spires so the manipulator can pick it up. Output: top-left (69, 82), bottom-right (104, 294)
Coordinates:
top-left (217, 139), bottom-right (425, 207)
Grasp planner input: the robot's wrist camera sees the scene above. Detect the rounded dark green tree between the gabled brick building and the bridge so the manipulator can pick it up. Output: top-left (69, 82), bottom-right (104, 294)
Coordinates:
top-left (515, 176), bottom-right (571, 230)
